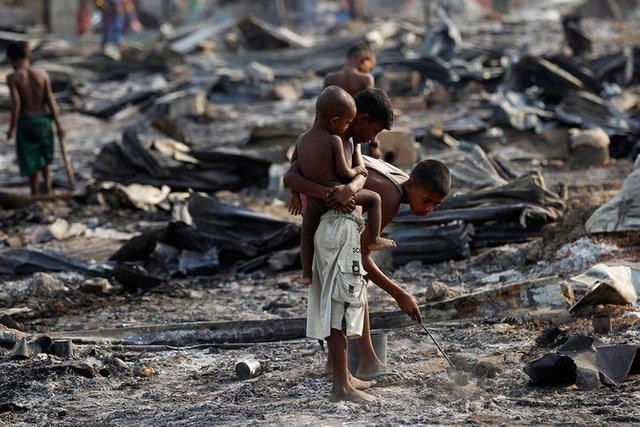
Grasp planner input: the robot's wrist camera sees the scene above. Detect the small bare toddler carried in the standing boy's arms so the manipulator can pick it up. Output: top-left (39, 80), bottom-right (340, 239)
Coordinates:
top-left (290, 86), bottom-right (395, 285)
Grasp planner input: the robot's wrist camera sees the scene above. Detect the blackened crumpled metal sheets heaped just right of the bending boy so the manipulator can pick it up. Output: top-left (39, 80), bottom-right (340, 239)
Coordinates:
top-left (392, 174), bottom-right (564, 265)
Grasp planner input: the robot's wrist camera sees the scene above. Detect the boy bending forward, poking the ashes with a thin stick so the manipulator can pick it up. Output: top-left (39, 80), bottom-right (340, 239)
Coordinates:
top-left (284, 124), bottom-right (451, 392)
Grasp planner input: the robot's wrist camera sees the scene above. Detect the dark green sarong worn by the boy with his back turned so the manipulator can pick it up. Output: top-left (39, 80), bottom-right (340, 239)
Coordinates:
top-left (16, 113), bottom-right (53, 176)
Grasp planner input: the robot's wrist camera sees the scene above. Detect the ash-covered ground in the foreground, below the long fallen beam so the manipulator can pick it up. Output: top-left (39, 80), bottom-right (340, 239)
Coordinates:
top-left (0, 312), bottom-right (640, 425)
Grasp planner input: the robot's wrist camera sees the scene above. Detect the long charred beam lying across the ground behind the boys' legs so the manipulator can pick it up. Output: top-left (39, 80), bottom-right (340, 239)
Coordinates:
top-left (47, 276), bottom-right (567, 346)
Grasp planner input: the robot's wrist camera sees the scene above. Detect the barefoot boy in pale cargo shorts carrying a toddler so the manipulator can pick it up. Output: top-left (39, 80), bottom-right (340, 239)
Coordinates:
top-left (285, 89), bottom-right (396, 402)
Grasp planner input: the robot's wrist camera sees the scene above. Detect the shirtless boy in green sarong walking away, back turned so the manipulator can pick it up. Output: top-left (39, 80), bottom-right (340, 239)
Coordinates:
top-left (7, 42), bottom-right (64, 195)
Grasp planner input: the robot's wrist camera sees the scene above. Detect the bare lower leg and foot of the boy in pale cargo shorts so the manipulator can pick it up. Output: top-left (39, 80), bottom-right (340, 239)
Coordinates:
top-left (327, 329), bottom-right (376, 402)
